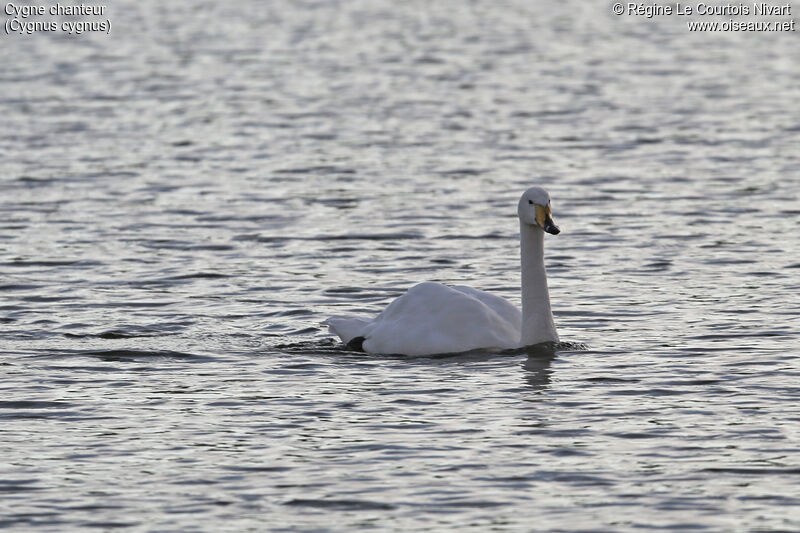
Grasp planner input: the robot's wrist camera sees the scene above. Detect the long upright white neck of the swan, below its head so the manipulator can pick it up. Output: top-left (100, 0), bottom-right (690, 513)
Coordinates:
top-left (520, 222), bottom-right (558, 346)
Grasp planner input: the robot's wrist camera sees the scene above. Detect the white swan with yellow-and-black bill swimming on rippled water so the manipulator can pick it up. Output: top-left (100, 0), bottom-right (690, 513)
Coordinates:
top-left (324, 187), bottom-right (561, 355)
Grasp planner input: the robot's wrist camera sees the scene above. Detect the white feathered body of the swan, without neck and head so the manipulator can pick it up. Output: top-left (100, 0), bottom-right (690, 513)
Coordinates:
top-left (327, 282), bottom-right (522, 355)
